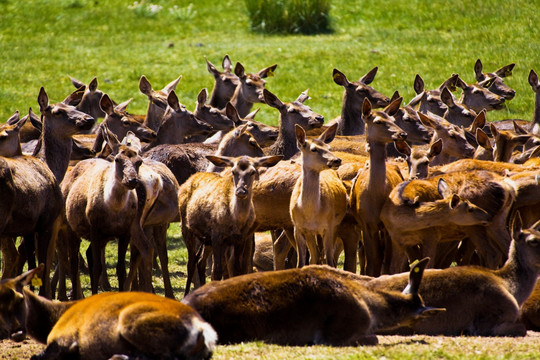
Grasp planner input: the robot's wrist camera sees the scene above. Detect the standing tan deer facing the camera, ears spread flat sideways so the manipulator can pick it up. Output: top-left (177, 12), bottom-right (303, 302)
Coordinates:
top-left (178, 155), bottom-right (282, 294)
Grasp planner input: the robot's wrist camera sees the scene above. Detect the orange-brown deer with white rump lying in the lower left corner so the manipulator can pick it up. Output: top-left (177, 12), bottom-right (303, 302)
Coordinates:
top-left (0, 266), bottom-right (217, 359)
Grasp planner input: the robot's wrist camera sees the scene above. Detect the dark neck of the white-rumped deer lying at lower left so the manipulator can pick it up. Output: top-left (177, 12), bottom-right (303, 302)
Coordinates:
top-left (23, 288), bottom-right (76, 344)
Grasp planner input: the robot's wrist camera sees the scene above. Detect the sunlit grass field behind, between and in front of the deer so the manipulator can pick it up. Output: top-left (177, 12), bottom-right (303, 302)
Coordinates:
top-left (0, 0), bottom-right (540, 359)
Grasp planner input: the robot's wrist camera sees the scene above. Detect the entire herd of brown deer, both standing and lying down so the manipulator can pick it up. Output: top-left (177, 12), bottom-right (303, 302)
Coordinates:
top-left (0, 56), bottom-right (540, 359)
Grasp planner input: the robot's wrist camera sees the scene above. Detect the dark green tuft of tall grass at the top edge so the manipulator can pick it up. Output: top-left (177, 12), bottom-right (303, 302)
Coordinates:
top-left (245, 0), bottom-right (332, 34)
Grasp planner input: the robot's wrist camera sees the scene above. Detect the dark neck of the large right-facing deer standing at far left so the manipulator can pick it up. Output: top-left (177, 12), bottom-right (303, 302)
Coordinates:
top-left (37, 123), bottom-right (73, 183)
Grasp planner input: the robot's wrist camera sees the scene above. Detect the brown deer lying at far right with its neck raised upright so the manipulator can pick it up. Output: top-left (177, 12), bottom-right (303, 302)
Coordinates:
top-left (370, 212), bottom-right (540, 336)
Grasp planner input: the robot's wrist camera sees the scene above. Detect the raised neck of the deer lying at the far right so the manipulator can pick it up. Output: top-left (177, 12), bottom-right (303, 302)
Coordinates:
top-left (495, 240), bottom-right (538, 306)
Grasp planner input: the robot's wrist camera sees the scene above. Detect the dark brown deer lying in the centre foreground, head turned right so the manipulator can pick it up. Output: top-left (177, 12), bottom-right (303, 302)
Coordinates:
top-left (182, 261), bottom-right (444, 346)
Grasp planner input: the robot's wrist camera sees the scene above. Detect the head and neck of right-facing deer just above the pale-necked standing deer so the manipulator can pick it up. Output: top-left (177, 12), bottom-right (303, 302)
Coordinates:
top-left (263, 89), bottom-right (324, 160)
